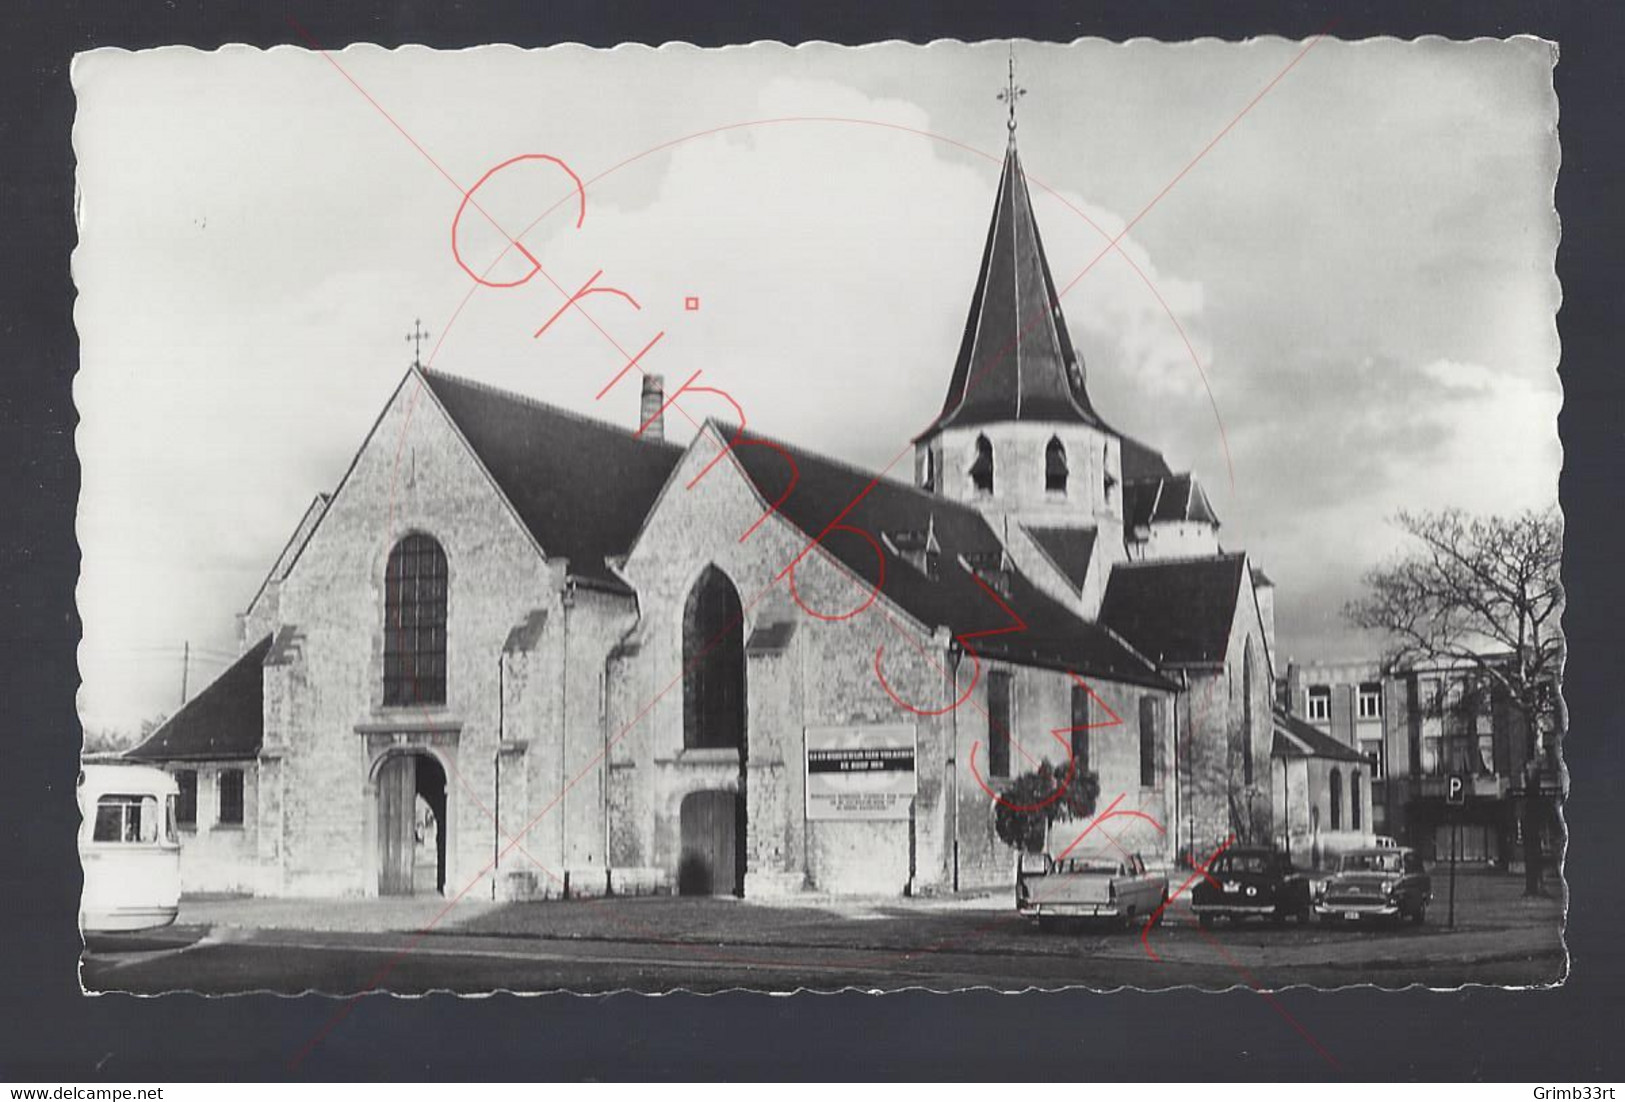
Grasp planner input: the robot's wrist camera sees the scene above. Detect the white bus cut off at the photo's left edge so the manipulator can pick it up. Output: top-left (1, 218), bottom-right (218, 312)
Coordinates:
top-left (80, 762), bottom-right (180, 933)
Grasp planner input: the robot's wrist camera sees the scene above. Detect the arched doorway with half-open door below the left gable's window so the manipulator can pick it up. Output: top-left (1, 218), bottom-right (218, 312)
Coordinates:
top-left (377, 753), bottom-right (447, 896)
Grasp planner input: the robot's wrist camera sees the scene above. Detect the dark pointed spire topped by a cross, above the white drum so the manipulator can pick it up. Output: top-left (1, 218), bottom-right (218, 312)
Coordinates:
top-left (928, 97), bottom-right (1100, 432)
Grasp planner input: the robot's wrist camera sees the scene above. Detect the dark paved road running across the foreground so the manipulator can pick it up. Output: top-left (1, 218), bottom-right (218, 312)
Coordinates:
top-left (83, 915), bottom-right (1563, 995)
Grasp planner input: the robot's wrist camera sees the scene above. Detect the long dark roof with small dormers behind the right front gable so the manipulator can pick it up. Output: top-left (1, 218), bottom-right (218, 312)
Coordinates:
top-left (723, 429), bottom-right (1170, 686)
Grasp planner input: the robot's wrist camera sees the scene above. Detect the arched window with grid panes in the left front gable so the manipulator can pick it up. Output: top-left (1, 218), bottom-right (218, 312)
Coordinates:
top-left (384, 533), bottom-right (447, 704)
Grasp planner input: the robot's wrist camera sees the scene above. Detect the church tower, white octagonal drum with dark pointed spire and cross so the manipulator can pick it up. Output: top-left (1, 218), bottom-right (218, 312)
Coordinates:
top-left (915, 65), bottom-right (1125, 575)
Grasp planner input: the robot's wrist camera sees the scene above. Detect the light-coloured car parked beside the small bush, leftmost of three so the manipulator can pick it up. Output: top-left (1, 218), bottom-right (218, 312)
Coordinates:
top-left (1016, 853), bottom-right (1168, 926)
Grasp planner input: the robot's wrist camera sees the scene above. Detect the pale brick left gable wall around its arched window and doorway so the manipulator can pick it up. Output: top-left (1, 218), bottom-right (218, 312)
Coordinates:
top-left (262, 377), bottom-right (562, 894)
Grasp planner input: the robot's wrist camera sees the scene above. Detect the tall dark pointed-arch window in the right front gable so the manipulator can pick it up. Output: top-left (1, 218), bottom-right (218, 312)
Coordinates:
top-left (683, 566), bottom-right (744, 756)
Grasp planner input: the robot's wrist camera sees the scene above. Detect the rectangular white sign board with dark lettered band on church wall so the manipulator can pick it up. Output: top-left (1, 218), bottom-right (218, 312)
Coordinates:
top-left (806, 723), bottom-right (917, 819)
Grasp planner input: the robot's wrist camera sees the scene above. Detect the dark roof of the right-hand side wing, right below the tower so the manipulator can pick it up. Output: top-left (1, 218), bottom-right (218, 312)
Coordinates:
top-left (1100, 553), bottom-right (1246, 665)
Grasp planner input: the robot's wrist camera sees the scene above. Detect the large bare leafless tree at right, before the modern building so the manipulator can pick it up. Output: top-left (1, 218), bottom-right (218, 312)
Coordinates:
top-left (1344, 507), bottom-right (1563, 894)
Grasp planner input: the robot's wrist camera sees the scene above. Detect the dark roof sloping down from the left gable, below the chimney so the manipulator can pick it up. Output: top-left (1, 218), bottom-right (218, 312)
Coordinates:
top-left (423, 371), bottom-right (683, 585)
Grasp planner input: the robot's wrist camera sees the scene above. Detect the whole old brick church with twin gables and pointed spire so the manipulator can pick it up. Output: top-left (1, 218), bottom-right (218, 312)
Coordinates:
top-left (130, 127), bottom-right (1276, 899)
